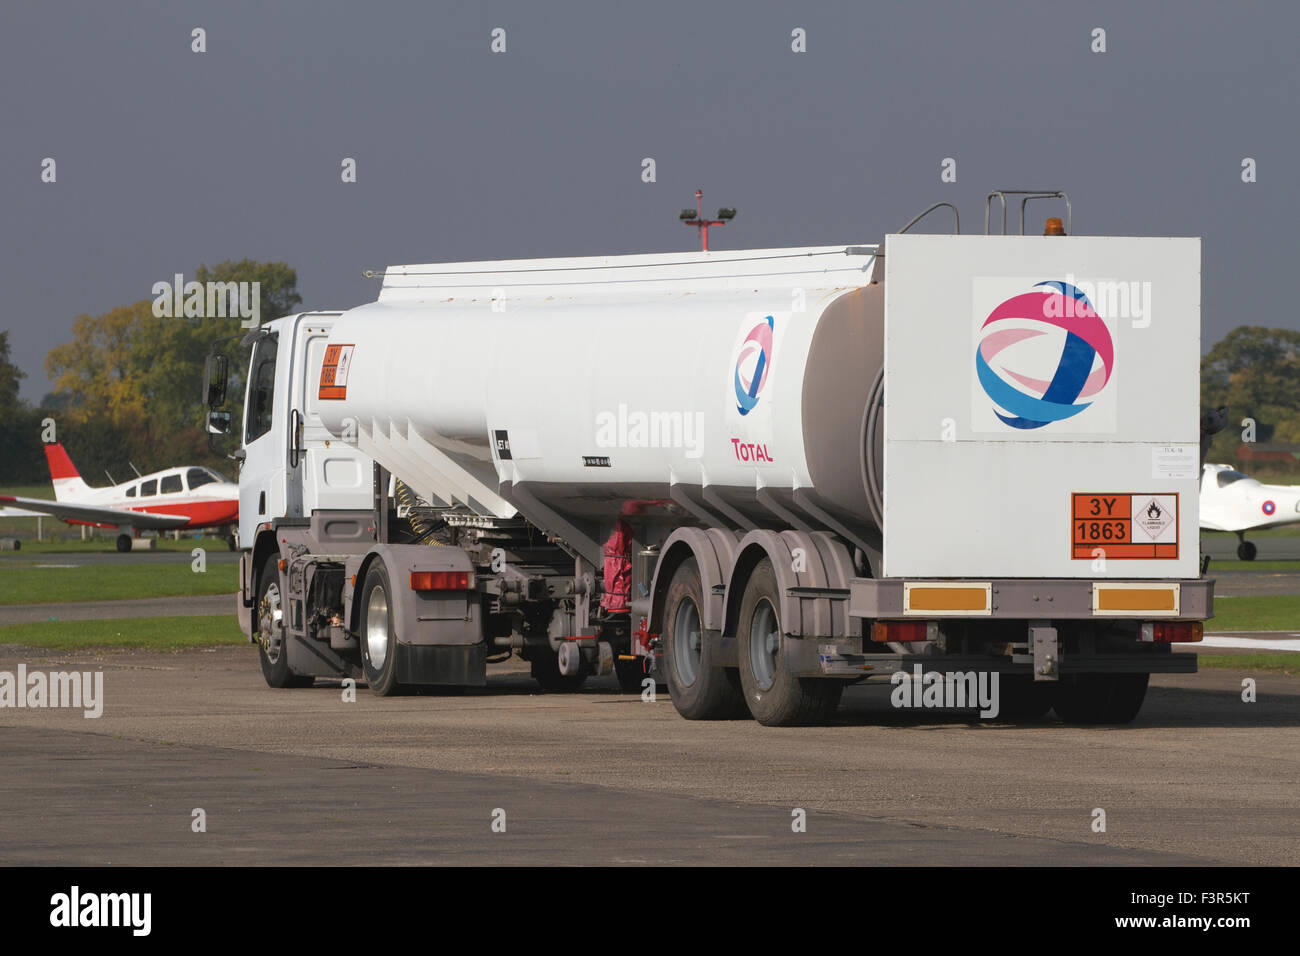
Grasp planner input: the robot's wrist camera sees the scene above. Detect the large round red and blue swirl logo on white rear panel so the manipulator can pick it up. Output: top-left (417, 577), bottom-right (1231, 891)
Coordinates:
top-left (975, 281), bottom-right (1115, 431)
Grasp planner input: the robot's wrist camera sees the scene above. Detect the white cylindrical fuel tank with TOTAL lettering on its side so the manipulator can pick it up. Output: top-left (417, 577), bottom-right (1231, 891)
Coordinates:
top-left (308, 246), bottom-right (884, 548)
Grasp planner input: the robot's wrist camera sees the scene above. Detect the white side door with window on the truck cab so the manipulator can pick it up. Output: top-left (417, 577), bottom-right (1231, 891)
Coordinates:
top-left (239, 330), bottom-right (287, 542)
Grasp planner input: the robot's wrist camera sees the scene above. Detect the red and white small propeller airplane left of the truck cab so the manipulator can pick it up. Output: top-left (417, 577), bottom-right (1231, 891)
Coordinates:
top-left (0, 445), bottom-right (239, 551)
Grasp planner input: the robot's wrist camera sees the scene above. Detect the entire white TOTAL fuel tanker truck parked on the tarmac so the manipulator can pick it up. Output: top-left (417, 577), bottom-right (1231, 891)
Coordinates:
top-left (205, 197), bottom-right (1213, 726)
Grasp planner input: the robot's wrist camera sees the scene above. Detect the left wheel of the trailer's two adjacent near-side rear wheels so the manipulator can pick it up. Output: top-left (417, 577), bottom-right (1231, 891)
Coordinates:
top-left (662, 558), bottom-right (749, 721)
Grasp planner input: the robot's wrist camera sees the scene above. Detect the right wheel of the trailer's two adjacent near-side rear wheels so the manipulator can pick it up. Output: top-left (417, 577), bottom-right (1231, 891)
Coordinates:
top-left (736, 558), bottom-right (844, 727)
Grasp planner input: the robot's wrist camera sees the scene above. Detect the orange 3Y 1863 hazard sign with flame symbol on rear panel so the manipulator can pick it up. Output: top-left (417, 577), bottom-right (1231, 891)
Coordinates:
top-left (1070, 492), bottom-right (1178, 561)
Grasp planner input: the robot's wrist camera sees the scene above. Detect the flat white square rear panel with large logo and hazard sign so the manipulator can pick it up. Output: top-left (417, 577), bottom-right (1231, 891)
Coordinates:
top-left (884, 235), bottom-right (1200, 578)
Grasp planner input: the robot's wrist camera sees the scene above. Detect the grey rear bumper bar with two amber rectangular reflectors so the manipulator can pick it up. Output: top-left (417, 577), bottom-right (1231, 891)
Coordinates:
top-left (849, 578), bottom-right (1214, 620)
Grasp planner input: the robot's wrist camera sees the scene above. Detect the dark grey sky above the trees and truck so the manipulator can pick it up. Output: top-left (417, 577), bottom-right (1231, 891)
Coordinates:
top-left (0, 0), bottom-right (1300, 399)
